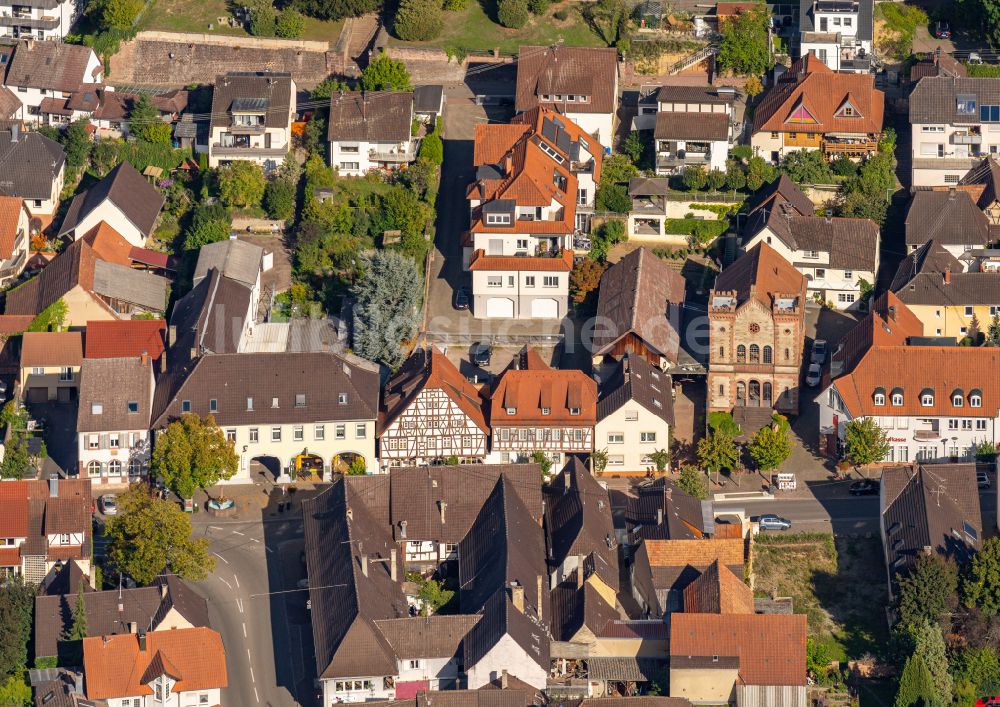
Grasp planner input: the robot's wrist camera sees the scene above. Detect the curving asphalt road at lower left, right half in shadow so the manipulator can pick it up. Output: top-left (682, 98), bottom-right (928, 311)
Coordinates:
top-left (188, 513), bottom-right (315, 707)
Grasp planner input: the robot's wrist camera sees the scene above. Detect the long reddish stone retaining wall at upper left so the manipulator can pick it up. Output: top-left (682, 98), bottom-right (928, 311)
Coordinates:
top-left (108, 32), bottom-right (346, 88)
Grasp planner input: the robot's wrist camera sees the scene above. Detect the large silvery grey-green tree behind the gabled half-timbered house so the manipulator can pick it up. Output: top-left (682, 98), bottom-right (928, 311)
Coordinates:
top-left (351, 251), bottom-right (423, 370)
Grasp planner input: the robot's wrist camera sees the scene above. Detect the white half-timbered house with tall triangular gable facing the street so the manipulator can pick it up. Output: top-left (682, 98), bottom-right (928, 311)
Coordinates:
top-left (378, 348), bottom-right (489, 466)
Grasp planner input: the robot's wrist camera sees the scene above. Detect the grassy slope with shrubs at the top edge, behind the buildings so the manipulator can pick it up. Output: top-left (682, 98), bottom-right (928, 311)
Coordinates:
top-left (390, 0), bottom-right (604, 55)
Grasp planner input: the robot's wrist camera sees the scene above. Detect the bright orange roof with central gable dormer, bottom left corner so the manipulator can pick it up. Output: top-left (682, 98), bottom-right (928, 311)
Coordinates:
top-left (83, 628), bottom-right (228, 700)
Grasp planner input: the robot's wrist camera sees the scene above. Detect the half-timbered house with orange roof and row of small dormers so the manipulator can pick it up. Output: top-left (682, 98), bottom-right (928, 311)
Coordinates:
top-left (489, 347), bottom-right (597, 473)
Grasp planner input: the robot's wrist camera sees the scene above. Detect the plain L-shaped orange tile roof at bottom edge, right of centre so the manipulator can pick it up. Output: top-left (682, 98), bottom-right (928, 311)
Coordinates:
top-left (670, 613), bottom-right (806, 686)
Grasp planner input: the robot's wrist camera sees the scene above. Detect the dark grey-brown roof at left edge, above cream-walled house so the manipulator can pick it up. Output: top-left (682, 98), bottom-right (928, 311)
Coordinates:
top-left (0, 129), bottom-right (66, 200)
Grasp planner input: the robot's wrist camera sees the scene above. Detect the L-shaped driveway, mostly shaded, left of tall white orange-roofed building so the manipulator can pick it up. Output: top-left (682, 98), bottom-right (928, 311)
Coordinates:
top-left (423, 85), bottom-right (561, 344)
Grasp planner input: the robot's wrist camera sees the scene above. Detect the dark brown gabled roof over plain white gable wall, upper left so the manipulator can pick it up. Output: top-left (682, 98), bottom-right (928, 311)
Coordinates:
top-left (59, 162), bottom-right (165, 237)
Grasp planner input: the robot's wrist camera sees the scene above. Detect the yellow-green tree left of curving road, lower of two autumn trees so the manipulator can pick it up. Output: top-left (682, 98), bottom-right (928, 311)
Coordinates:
top-left (105, 487), bottom-right (215, 585)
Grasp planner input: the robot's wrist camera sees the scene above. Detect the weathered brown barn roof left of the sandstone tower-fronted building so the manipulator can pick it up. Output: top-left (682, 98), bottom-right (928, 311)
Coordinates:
top-left (594, 248), bottom-right (684, 363)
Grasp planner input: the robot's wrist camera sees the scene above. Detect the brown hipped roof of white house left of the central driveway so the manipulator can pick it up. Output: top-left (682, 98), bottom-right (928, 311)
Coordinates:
top-left (326, 92), bottom-right (413, 142)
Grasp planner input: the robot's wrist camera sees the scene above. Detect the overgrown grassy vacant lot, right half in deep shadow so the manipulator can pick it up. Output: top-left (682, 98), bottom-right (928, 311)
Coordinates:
top-left (754, 533), bottom-right (888, 661)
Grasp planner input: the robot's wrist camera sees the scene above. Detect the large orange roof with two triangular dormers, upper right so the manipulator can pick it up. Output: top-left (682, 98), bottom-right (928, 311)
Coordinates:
top-left (751, 54), bottom-right (885, 134)
